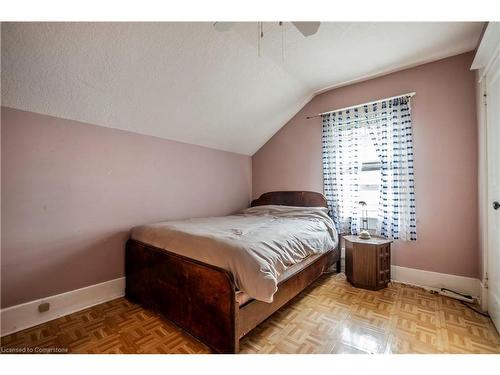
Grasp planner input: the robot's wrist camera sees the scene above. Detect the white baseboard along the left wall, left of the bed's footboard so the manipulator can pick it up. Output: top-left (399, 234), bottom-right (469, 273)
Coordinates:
top-left (0, 277), bottom-right (125, 336)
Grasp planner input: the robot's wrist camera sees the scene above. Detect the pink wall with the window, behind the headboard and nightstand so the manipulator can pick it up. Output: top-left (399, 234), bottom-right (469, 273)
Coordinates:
top-left (252, 52), bottom-right (479, 277)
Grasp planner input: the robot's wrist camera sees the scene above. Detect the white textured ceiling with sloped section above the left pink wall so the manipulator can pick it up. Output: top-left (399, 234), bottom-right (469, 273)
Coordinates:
top-left (1, 22), bottom-right (482, 155)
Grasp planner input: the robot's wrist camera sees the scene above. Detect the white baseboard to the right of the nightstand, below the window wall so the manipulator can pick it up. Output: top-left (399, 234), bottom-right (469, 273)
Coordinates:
top-left (391, 266), bottom-right (482, 300)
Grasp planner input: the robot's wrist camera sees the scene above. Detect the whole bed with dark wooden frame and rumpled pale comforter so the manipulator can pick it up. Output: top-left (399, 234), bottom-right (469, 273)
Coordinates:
top-left (125, 191), bottom-right (340, 353)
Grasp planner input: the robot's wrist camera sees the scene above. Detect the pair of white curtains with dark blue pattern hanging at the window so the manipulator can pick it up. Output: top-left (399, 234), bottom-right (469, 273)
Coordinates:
top-left (323, 96), bottom-right (417, 241)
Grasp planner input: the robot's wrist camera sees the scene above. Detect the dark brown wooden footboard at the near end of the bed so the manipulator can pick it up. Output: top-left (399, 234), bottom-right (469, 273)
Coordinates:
top-left (125, 240), bottom-right (239, 353)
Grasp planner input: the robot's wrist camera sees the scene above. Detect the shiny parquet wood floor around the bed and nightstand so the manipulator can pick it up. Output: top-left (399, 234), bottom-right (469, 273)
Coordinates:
top-left (1, 274), bottom-right (500, 353)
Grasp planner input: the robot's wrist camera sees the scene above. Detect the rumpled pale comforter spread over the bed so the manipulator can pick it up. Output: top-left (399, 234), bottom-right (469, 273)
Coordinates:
top-left (132, 205), bottom-right (337, 302)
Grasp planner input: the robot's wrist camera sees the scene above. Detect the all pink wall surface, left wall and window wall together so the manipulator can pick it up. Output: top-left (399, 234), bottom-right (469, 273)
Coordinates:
top-left (1, 53), bottom-right (479, 307)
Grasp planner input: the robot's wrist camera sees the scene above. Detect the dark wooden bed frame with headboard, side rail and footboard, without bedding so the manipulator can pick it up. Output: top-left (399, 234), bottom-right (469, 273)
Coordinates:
top-left (125, 191), bottom-right (340, 353)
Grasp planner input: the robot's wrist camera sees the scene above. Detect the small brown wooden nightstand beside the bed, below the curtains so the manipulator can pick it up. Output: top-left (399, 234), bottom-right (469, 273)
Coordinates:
top-left (344, 236), bottom-right (392, 290)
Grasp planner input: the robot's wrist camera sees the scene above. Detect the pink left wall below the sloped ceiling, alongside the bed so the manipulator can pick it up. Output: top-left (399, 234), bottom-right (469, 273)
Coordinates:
top-left (1, 107), bottom-right (251, 307)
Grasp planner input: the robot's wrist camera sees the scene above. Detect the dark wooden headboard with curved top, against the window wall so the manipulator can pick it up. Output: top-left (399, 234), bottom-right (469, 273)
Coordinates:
top-left (251, 191), bottom-right (328, 207)
